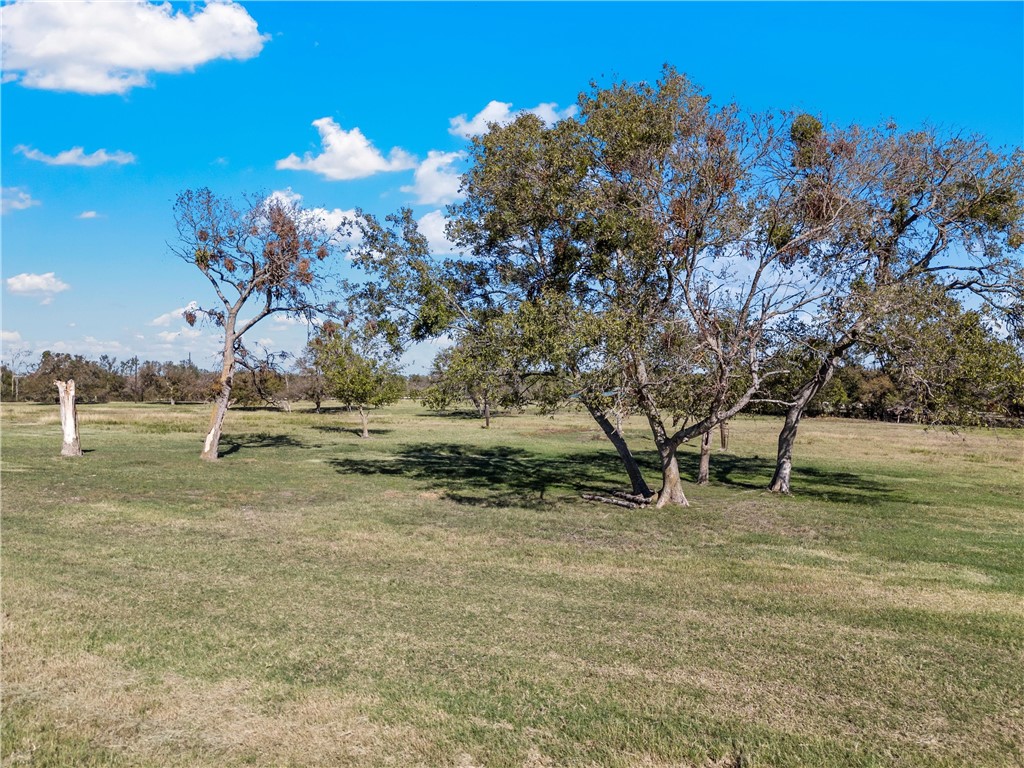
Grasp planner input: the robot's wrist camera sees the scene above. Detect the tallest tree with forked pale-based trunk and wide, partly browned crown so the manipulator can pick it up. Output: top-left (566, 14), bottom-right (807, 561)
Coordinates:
top-left (450, 70), bottom-right (848, 505)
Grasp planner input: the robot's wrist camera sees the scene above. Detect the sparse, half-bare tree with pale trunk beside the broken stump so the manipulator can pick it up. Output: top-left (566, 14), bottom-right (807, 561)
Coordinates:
top-left (171, 188), bottom-right (342, 461)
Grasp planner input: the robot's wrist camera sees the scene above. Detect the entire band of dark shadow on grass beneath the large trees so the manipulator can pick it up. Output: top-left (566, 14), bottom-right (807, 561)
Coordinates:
top-left (329, 442), bottom-right (895, 506)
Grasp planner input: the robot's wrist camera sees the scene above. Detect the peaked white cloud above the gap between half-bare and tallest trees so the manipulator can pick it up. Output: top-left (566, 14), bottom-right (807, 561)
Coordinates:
top-left (275, 118), bottom-right (416, 181)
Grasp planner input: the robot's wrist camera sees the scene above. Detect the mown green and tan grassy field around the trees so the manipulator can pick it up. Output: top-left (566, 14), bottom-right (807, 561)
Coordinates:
top-left (0, 403), bottom-right (1024, 768)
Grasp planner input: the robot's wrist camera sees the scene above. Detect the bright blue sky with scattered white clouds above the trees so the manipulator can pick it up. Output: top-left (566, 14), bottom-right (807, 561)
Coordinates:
top-left (0, 0), bottom-right (1024, 371)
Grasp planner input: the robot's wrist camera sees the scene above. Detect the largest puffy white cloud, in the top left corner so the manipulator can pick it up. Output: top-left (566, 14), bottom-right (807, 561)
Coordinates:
top-left (0, 0), bottom-right (269, 94)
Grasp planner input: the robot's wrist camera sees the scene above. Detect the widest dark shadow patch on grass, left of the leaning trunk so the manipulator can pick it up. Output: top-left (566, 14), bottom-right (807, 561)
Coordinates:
top-left (329, 442), bottom-right (622, 507)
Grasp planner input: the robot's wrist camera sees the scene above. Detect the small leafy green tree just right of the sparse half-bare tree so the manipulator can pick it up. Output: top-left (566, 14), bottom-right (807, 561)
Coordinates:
top-left (308, 323), bottom-right (406, 437)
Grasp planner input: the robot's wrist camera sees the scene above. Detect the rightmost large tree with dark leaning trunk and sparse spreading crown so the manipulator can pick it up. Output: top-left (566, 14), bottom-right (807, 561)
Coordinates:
top-left (769, 118), bottom-right (1024, 493)
